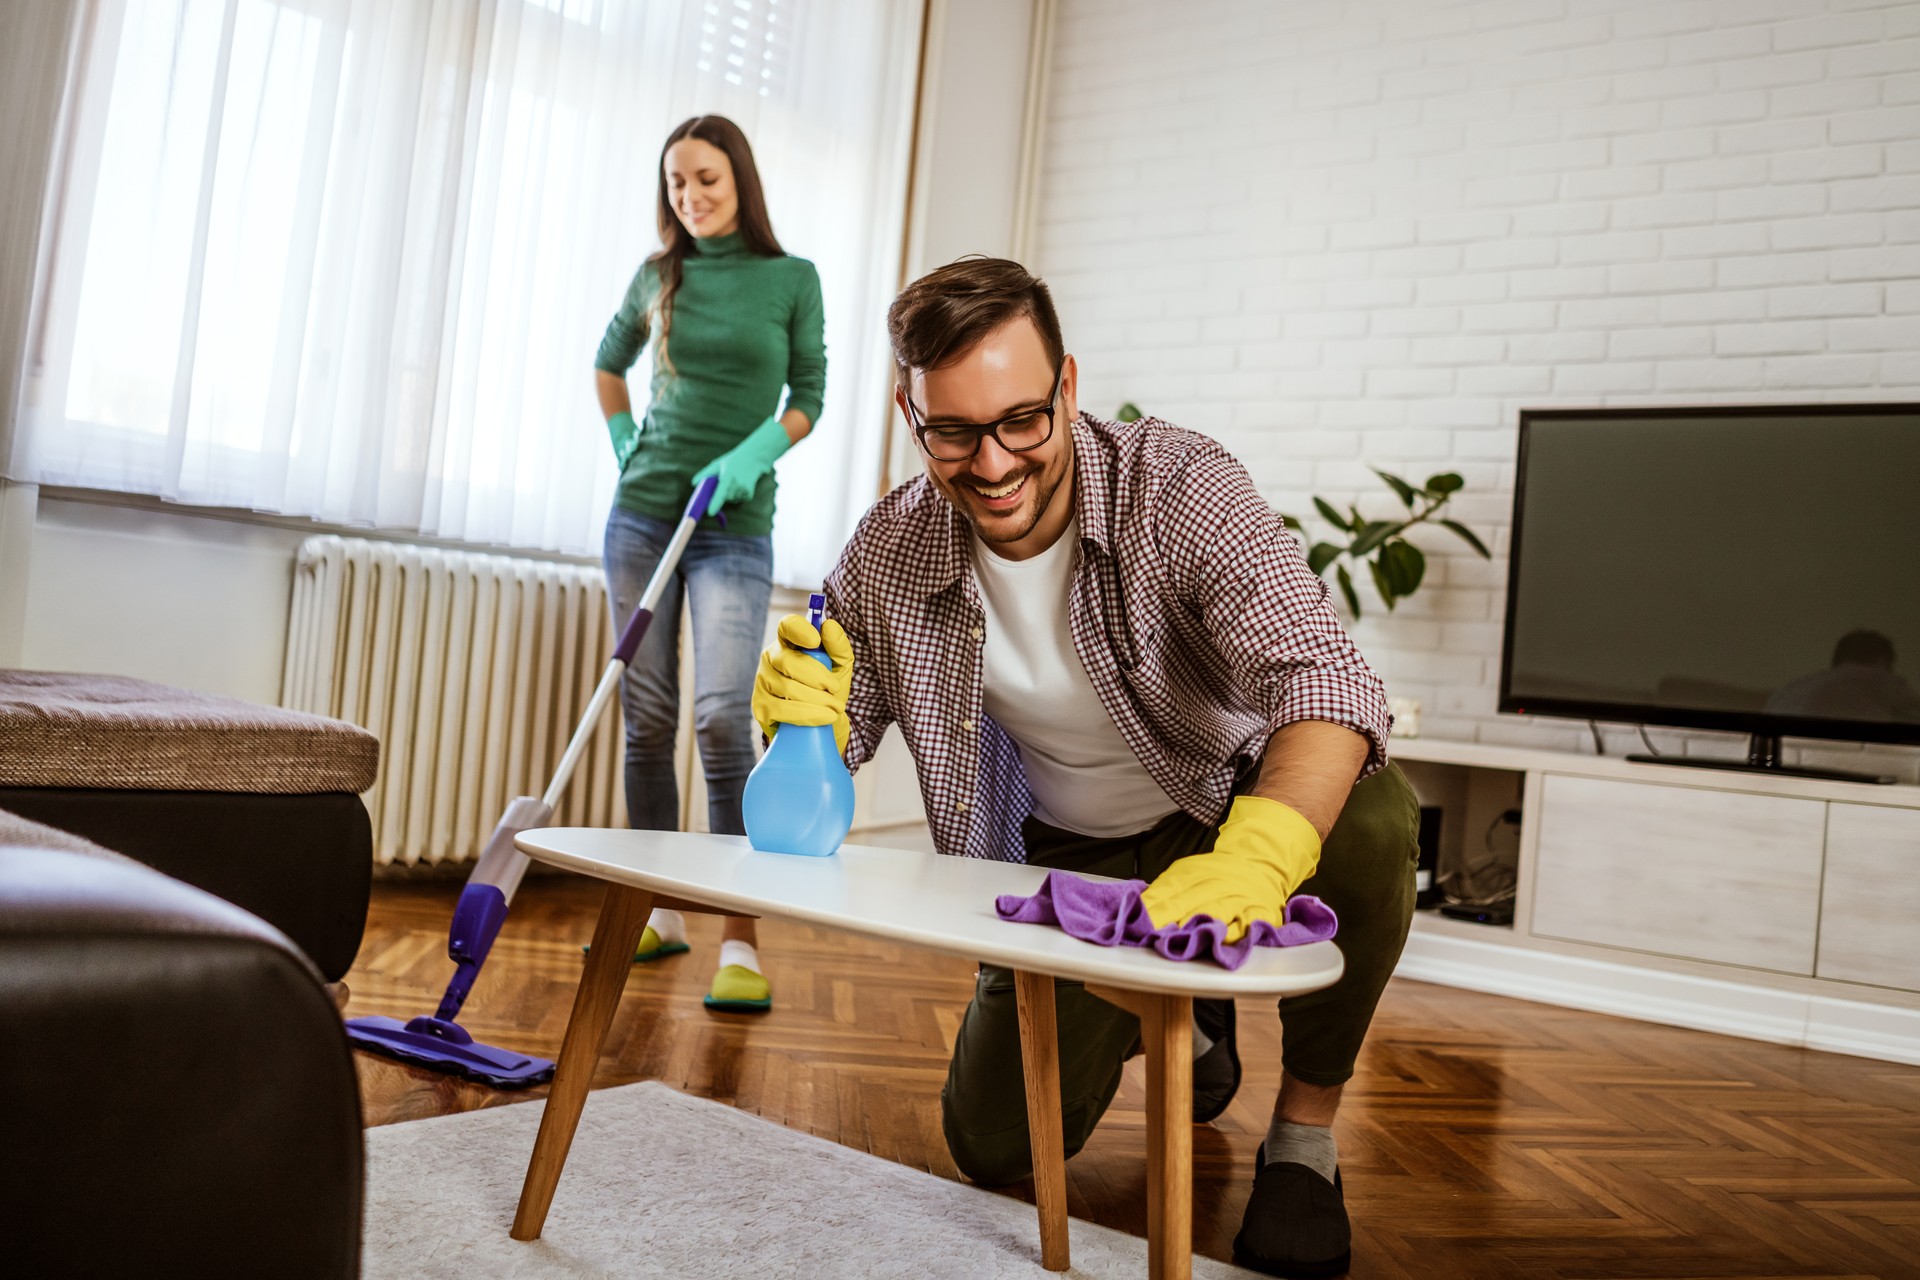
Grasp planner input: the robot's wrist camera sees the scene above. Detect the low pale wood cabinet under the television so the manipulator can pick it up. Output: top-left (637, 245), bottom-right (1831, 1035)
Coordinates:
top-left (1390, 739), bottom-right (1920, 1063)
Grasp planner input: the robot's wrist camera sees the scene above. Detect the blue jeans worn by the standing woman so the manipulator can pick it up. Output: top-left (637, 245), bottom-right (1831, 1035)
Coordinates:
top-left (605, 507), bottom-right (774, 835)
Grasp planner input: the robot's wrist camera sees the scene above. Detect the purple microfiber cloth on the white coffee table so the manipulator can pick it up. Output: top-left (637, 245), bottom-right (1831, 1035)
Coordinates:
top-left (993, 871), bottom-right (1340, 969)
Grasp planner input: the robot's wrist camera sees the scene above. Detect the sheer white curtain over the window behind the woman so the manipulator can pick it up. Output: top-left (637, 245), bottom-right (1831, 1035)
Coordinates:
top-left (8, 0), bottom-right (920, 583)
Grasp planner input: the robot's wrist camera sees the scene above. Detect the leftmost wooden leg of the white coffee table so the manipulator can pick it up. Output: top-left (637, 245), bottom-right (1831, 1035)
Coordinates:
top-left (513, 885), bottom-right (653, 1240)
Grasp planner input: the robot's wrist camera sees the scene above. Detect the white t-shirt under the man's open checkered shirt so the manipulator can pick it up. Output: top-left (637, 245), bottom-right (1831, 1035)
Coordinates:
top-left (973, 520), bottom-right (1179, 837)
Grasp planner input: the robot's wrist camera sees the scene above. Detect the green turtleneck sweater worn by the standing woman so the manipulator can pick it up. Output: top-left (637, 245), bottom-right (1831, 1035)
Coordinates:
top-left (593, 232), bottom-right (828, 533)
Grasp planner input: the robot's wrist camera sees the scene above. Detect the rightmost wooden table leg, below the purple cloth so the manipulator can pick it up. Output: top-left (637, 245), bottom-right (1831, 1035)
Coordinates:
top-left (1087, 983), bottom-right (1194, 1280)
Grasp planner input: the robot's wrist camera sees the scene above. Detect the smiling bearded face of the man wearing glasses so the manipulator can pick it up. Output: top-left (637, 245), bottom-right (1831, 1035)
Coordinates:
top-left (895, 315), bottom-right (1077, 560)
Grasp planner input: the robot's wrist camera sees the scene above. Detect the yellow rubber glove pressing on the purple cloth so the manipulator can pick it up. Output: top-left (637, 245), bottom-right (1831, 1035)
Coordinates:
top-left (1140, 796), bottom-right (1319, 942)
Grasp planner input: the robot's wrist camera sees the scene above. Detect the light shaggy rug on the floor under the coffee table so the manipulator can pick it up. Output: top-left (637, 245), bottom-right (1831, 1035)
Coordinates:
top-left (365, 1082), bottom-right (1252, 1280)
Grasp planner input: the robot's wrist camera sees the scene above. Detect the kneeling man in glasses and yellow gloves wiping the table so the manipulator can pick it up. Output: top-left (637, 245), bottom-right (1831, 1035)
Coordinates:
top-left (755, 259), bottom-right (1417, 1276)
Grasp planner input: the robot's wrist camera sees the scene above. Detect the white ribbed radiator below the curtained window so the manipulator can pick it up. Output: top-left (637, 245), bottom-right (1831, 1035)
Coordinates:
top-left (280, 535), bottom-right (626, 865)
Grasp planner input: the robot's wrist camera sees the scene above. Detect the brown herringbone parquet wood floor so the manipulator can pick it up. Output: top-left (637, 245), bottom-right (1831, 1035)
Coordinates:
top-left (348, 877), bottom-right (1920, 1280)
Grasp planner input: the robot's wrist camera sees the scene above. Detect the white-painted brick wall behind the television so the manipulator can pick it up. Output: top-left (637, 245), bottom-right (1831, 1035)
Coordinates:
top-left (1035, 0), bottom-right (1920, 779)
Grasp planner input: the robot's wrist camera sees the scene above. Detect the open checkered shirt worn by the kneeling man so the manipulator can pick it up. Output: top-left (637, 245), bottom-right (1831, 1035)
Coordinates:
top-left (826, 413), bottom-right (1390, 862)
